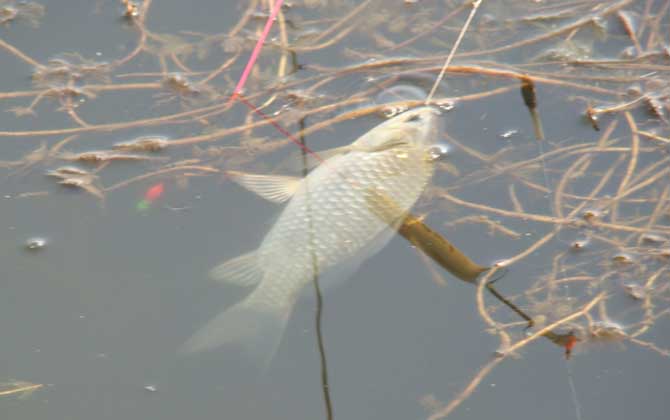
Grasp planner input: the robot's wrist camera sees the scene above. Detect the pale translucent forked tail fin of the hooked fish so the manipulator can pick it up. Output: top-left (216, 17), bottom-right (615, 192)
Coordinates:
top-left (181, 289), bottom-right (292, 367)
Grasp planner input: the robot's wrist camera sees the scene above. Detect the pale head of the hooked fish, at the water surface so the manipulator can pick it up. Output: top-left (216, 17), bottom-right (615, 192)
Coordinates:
top-left (352, 106), bottom-right (442, 152)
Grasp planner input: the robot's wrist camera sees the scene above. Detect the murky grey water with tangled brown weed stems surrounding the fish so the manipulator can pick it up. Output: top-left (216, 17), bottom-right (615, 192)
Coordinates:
top-left (0, 0), bottom-right (670, 420)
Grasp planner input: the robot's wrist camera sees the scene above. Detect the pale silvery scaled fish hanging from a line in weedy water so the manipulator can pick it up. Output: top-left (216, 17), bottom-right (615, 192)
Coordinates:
top-left (181, 106), bottom-right (441, 366)
